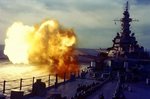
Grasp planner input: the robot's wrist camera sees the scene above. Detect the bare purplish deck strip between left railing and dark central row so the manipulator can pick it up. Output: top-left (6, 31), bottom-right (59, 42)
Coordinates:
top-left (27, 79), bottom-right (99, 99)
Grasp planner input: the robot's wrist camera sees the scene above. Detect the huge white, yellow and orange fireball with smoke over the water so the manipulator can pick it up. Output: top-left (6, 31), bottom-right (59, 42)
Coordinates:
top-left (4, 20), bottom-right (78, 74)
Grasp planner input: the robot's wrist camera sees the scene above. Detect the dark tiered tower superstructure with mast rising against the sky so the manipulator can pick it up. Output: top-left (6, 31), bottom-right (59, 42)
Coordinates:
top-left (109, 2), bottom-right (148, 58)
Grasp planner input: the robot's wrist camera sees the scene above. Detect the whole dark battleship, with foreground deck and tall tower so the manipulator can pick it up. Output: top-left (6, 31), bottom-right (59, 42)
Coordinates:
top-left (0, 2), bottom-right (150, 99)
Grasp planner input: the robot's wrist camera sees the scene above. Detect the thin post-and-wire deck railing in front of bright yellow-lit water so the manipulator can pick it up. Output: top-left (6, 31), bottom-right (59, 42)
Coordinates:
top-left (0, 74), bottom-right (66, 94)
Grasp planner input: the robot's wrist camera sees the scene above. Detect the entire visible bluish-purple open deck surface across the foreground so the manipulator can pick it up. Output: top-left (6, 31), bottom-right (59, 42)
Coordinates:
top-left (11, 74), bottom-right (150, 99)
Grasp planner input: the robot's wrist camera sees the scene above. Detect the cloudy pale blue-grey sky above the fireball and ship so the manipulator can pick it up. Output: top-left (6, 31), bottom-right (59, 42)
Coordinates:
top-left (0, 0), bottom-right (150, 49)
